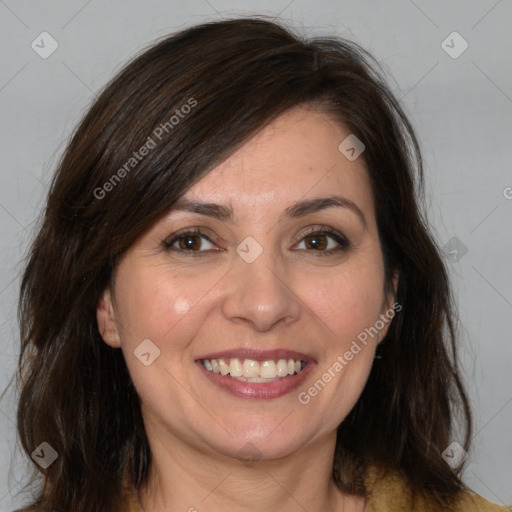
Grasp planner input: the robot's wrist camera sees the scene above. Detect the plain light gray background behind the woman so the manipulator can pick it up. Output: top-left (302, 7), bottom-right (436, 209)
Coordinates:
top-left (0, 0), bottom-right (512, 511)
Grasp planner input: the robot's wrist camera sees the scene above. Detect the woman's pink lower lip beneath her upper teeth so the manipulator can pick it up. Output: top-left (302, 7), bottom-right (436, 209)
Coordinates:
top-left (196, 361), bottom-right (315, 399)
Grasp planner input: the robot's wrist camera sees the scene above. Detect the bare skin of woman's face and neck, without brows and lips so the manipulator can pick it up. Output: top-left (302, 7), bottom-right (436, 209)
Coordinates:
top-left (97, 107), bottom-right (396, 512)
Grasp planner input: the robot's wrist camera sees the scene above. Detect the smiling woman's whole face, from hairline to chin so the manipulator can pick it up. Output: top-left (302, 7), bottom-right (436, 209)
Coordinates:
top-left (98, 108), bottom-right (393, 458)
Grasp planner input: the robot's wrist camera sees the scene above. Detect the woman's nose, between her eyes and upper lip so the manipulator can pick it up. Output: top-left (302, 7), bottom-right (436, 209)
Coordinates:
top-left (222, 251), bottom-right (302, 332)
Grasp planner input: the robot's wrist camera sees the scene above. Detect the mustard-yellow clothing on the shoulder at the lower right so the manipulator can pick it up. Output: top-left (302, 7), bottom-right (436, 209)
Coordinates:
top-left (365, 468), bottom-right (512, 512)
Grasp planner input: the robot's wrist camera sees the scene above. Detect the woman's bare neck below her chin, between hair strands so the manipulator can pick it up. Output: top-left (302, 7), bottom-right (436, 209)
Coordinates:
top-left (140, 426), bottom-right (364, 512)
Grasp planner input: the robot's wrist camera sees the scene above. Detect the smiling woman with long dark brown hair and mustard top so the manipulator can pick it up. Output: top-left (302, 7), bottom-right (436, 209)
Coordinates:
top-left (11, 18), bottom-right (505, 512)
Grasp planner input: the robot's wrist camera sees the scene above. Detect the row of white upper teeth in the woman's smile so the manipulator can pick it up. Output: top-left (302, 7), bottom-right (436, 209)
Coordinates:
top-left (202, 358), bottom-right (306, 382)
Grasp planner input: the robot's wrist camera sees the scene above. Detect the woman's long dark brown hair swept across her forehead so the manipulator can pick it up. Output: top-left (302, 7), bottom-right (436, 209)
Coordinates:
top-left (8, 17), bottom-right (471, 512)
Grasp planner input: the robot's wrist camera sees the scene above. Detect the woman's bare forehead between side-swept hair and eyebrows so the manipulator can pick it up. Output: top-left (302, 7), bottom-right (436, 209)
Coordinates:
top-left (184, 107), bottom-right (373, 219)
